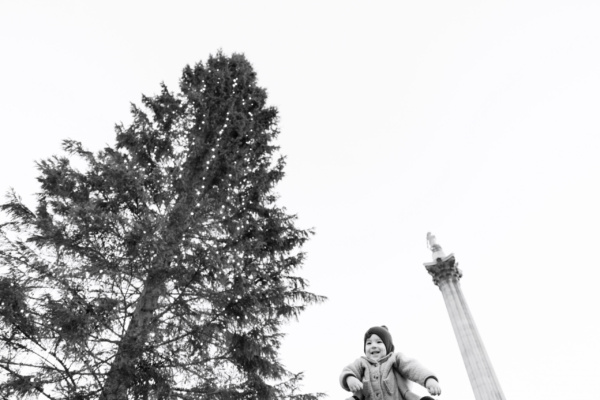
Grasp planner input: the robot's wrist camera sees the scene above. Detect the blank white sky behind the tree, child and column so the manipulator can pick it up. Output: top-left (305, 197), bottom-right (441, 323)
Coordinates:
top-left (0, 0), bottom-right (600, 400)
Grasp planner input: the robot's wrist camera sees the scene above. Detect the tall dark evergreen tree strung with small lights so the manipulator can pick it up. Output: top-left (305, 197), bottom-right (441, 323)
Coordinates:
top-left (0, 53), bottom-right (323, 400)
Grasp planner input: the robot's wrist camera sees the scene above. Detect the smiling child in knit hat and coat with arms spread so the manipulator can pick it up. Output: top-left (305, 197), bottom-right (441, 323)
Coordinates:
top-left (340, 326), bottom-right (442, 400)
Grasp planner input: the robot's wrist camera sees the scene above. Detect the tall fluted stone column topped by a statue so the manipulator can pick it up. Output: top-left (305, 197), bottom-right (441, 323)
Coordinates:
top-left (425, 233), bottom-right (505, 400)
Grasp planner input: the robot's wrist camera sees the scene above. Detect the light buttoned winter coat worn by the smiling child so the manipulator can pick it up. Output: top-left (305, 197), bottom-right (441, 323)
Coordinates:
top-left (340, 353), bottom-right (437, 400)
